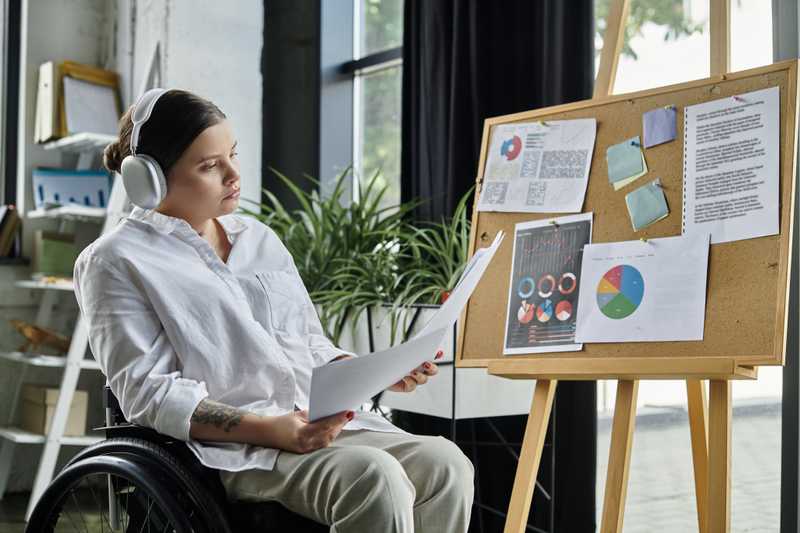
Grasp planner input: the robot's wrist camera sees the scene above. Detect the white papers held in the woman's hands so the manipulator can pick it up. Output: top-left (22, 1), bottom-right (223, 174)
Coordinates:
top-left (308, 231), bottom-right (504, 421)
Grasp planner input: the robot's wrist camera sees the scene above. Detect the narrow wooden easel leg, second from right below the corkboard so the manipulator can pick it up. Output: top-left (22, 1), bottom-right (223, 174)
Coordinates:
top-left (686, 379), bottom-right (708, 533)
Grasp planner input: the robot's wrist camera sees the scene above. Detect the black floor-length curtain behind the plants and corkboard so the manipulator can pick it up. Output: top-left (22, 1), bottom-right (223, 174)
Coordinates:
top-left (402, 0), bottom-right (597, 533)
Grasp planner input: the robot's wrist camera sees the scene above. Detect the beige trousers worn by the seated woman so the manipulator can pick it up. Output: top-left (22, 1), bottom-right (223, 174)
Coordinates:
top-left (220, 429), bottom-right (475, 533)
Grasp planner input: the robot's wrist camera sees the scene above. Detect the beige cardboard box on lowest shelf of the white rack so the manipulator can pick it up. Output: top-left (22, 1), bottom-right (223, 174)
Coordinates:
top-left (21, 384), bottom-right (89, 437)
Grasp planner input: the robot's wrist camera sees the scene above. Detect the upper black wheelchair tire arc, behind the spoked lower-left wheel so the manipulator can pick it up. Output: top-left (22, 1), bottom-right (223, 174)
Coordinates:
top-left (67, 437), bottom-right (232, 533)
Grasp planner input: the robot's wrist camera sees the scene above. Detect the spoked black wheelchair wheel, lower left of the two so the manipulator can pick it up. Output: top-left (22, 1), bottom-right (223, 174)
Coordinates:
top-left (25, 455), bottom-right (195, 533)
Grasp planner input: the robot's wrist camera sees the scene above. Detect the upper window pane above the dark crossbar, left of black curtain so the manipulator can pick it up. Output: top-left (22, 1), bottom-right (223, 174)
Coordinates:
top-left (354, 0), bottom-right (403, 57)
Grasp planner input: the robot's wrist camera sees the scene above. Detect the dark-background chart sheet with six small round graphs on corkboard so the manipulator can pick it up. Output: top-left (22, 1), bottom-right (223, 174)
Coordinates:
top-left (503, 213), bottom-right (592, 355)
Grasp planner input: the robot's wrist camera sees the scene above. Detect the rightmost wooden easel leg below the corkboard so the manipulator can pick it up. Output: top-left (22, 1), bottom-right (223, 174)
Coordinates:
top-left (708, 380), bottom-right (731, 533)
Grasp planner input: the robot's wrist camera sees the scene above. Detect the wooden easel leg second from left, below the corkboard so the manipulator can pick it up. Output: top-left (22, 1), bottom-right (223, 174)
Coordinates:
top-left (600, 380), bottom-right (639, 533)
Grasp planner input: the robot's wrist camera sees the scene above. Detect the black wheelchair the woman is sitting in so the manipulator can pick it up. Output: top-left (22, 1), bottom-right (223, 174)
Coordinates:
top-left (25, 386), bottom-right (329, 533)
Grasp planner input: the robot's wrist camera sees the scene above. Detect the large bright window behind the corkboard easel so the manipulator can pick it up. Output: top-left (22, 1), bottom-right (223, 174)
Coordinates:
top-left (595, 0), bottom-right (782, 531)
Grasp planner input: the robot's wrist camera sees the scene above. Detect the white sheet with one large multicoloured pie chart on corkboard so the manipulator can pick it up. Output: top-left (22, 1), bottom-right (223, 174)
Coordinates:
top-left (575, 233), bottom-right (709, 342)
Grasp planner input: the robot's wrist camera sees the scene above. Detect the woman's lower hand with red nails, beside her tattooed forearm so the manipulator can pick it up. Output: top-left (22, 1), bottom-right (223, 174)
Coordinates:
top-left (264, 410), bottom-right (354, 453)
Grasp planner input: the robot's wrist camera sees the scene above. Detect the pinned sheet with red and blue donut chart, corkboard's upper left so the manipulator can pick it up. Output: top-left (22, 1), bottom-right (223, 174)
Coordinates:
top-left (478, 118), bottom-right (597, 213)
